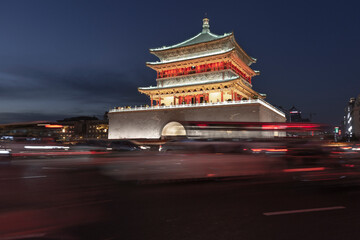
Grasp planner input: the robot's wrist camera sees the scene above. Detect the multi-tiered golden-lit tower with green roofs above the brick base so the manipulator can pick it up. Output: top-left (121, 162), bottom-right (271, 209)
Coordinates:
top-left (139, 18), bottom-right (265, 106)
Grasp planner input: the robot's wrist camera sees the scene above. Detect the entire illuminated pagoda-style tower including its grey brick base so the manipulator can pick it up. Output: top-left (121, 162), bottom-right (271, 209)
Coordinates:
top-left (108, 18), bottom-right (286, 139)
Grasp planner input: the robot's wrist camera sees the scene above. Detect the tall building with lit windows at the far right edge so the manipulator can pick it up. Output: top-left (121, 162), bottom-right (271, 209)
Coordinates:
top-left (342, 95), bottom-right (360, 140)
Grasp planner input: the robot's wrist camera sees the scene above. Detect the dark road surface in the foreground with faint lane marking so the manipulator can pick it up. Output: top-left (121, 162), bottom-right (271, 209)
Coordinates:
top-left (0, 155), bottom-right (360, 239)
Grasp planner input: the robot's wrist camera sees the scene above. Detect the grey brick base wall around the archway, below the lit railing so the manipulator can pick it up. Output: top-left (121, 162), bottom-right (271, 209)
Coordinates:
top-left (108, 103), bottom-right (286, 139)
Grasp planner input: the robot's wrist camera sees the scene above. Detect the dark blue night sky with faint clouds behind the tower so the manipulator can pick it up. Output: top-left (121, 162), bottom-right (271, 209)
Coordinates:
top-left (0, 0), bottom-right (360, 124)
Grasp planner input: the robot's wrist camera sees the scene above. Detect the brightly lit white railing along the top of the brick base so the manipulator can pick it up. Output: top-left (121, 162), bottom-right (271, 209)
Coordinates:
top-left (109, 99), bottom-right (285, 117)
